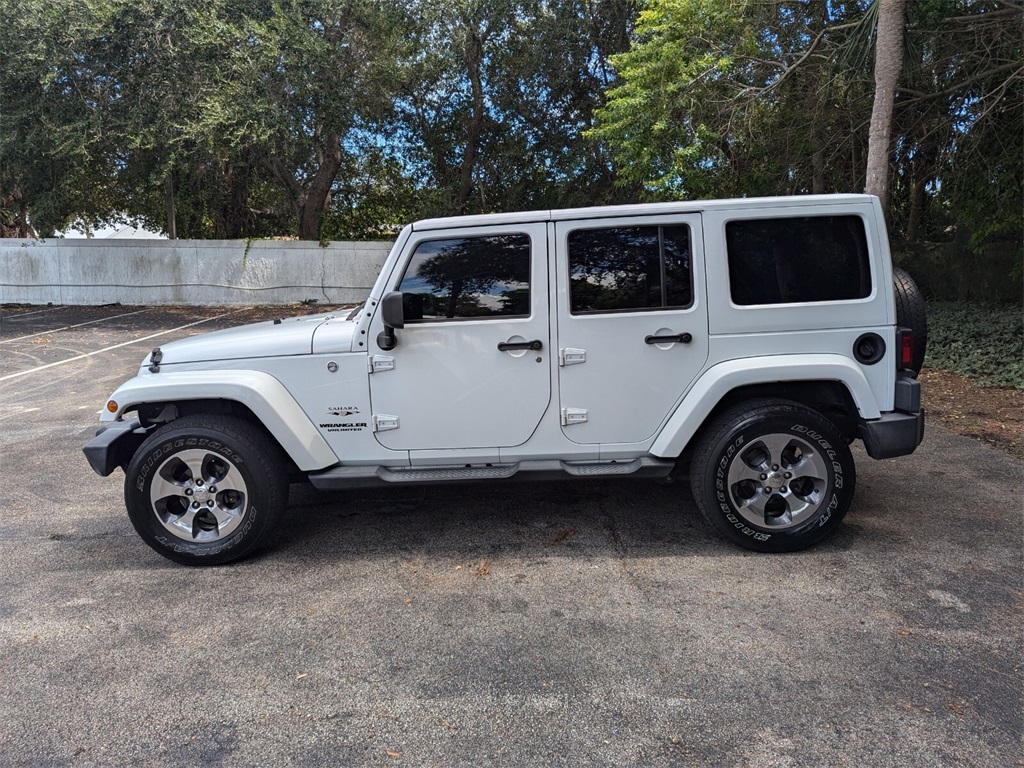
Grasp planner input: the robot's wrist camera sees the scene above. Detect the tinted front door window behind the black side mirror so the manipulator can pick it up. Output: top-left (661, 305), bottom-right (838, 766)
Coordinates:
top-left (398, 233), bottom-right (529, 323)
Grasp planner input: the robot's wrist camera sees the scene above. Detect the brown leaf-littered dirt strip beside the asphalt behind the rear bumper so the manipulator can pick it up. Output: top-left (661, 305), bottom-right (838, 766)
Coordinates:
top-left (920, 368), bottom-right (1024, 459)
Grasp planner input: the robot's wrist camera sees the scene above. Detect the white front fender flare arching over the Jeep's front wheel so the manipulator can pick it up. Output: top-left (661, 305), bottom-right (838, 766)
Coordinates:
top-left (99, 371), bottom-right (338, 472)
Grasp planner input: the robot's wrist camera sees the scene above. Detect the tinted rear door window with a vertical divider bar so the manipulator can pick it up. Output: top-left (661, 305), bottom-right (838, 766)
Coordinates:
top-left (568, 225), bottom-right (692, 314)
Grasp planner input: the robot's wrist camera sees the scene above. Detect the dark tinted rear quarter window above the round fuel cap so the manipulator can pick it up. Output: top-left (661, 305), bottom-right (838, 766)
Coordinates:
top-left (725, 216), bottom-right (871, 306)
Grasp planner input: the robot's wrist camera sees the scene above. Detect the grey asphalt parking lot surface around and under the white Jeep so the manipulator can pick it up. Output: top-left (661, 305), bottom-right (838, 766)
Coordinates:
top-left (0, 306), bottom-right (1024, 767)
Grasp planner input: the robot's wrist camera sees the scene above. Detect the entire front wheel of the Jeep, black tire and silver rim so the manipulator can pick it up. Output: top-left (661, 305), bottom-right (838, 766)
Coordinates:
top-left (125, 415), bottom-right (288, 565)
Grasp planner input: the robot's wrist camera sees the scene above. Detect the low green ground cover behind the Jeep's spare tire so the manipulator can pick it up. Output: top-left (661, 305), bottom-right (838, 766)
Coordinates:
top-left (925, 301), bottom-right (1024, 390)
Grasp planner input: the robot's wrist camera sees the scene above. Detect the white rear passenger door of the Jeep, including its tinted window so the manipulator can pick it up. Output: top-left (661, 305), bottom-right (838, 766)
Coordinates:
top-left (555, 213), bottom-right (708, 444)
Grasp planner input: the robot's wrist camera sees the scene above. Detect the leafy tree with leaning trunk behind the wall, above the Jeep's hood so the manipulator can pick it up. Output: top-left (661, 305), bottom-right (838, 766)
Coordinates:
top-left (185, 0), bottom-right (397, 240)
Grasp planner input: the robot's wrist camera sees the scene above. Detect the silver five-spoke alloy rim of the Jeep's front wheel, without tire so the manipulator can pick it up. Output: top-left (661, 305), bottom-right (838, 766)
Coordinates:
top-left (150, 449), bottom-right (249, 542)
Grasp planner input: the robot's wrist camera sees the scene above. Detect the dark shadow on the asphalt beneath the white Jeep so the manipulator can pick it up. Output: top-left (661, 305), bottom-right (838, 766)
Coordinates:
top-left (263, 480), bottom-right (859, 561)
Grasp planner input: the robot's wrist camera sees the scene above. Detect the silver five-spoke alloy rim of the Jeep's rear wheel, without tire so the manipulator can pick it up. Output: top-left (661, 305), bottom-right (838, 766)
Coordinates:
top-left (727, 433), bottom-right (829, 529)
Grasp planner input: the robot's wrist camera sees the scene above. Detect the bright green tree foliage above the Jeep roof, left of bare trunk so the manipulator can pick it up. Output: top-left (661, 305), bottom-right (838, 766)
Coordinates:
top-left (591, 0), bottom-right (870, 199)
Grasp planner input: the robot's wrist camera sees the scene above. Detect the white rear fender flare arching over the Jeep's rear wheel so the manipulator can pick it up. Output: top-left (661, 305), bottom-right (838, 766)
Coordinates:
top-left (650, 354), bottom-right (882, 457)
